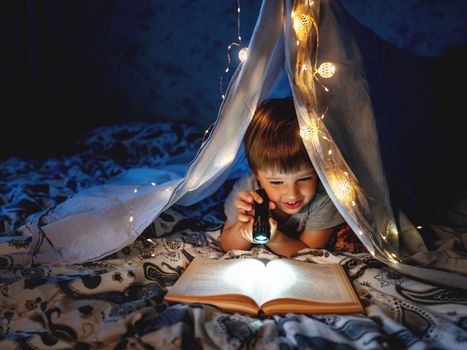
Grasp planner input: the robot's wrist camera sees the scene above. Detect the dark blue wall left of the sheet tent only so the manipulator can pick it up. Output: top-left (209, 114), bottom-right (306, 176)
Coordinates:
top-left (0, 0), bottom-right (261, 158)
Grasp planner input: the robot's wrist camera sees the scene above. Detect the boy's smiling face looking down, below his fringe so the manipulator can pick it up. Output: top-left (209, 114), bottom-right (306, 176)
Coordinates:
top-left (256, 167), bottom-right (318, 215)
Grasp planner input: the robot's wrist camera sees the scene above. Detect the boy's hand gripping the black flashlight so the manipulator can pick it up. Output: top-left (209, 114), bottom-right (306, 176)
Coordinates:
top-left (235, 191), bottom-right (277, 244)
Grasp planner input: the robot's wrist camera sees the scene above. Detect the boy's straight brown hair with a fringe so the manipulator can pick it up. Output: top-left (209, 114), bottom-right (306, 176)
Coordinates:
top-left (243, 98), bottom-right (312, 173)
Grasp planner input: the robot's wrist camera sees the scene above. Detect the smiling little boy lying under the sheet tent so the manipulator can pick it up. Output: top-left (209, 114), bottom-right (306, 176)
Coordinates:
top-left (220, 98), bottom-right (344, 257)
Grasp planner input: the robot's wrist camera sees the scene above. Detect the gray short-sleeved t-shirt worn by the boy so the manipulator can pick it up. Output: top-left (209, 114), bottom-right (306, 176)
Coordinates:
top-left (224, 174), bottom-right (345, 239)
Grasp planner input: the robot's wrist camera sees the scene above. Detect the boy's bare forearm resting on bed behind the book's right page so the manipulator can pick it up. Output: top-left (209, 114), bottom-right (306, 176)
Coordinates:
top-left (267, 227), bottom-right (335, 258)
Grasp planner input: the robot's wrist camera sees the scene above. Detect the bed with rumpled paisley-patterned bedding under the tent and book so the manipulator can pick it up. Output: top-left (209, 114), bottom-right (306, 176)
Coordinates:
top-left (0, 122), bottom-right (467, 349)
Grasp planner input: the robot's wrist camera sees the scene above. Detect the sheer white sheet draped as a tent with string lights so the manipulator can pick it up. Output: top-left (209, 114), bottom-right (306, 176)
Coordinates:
top-left (25, 0), bottom-right (467, 288)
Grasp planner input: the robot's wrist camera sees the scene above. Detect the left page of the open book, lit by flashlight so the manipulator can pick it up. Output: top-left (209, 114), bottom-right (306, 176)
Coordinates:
top-left (169, 257), bottom-right (265, 305)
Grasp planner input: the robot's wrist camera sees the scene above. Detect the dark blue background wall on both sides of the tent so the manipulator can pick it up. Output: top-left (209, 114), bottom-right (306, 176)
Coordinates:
top-left (0, 0), bottom-right (467, 224)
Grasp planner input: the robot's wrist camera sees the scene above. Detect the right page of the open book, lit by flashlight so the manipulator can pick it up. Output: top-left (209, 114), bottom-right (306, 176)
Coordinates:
top-left (260, 259), bottom-right (353, 305)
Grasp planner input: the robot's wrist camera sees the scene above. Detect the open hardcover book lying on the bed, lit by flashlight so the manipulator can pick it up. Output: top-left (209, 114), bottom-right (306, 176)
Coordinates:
top-left (164, 257), bottom-right (365, 315)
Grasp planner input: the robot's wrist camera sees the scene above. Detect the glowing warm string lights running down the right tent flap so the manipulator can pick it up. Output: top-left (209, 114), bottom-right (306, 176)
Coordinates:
top-left (296, 0), bottom-right (399, 263)
